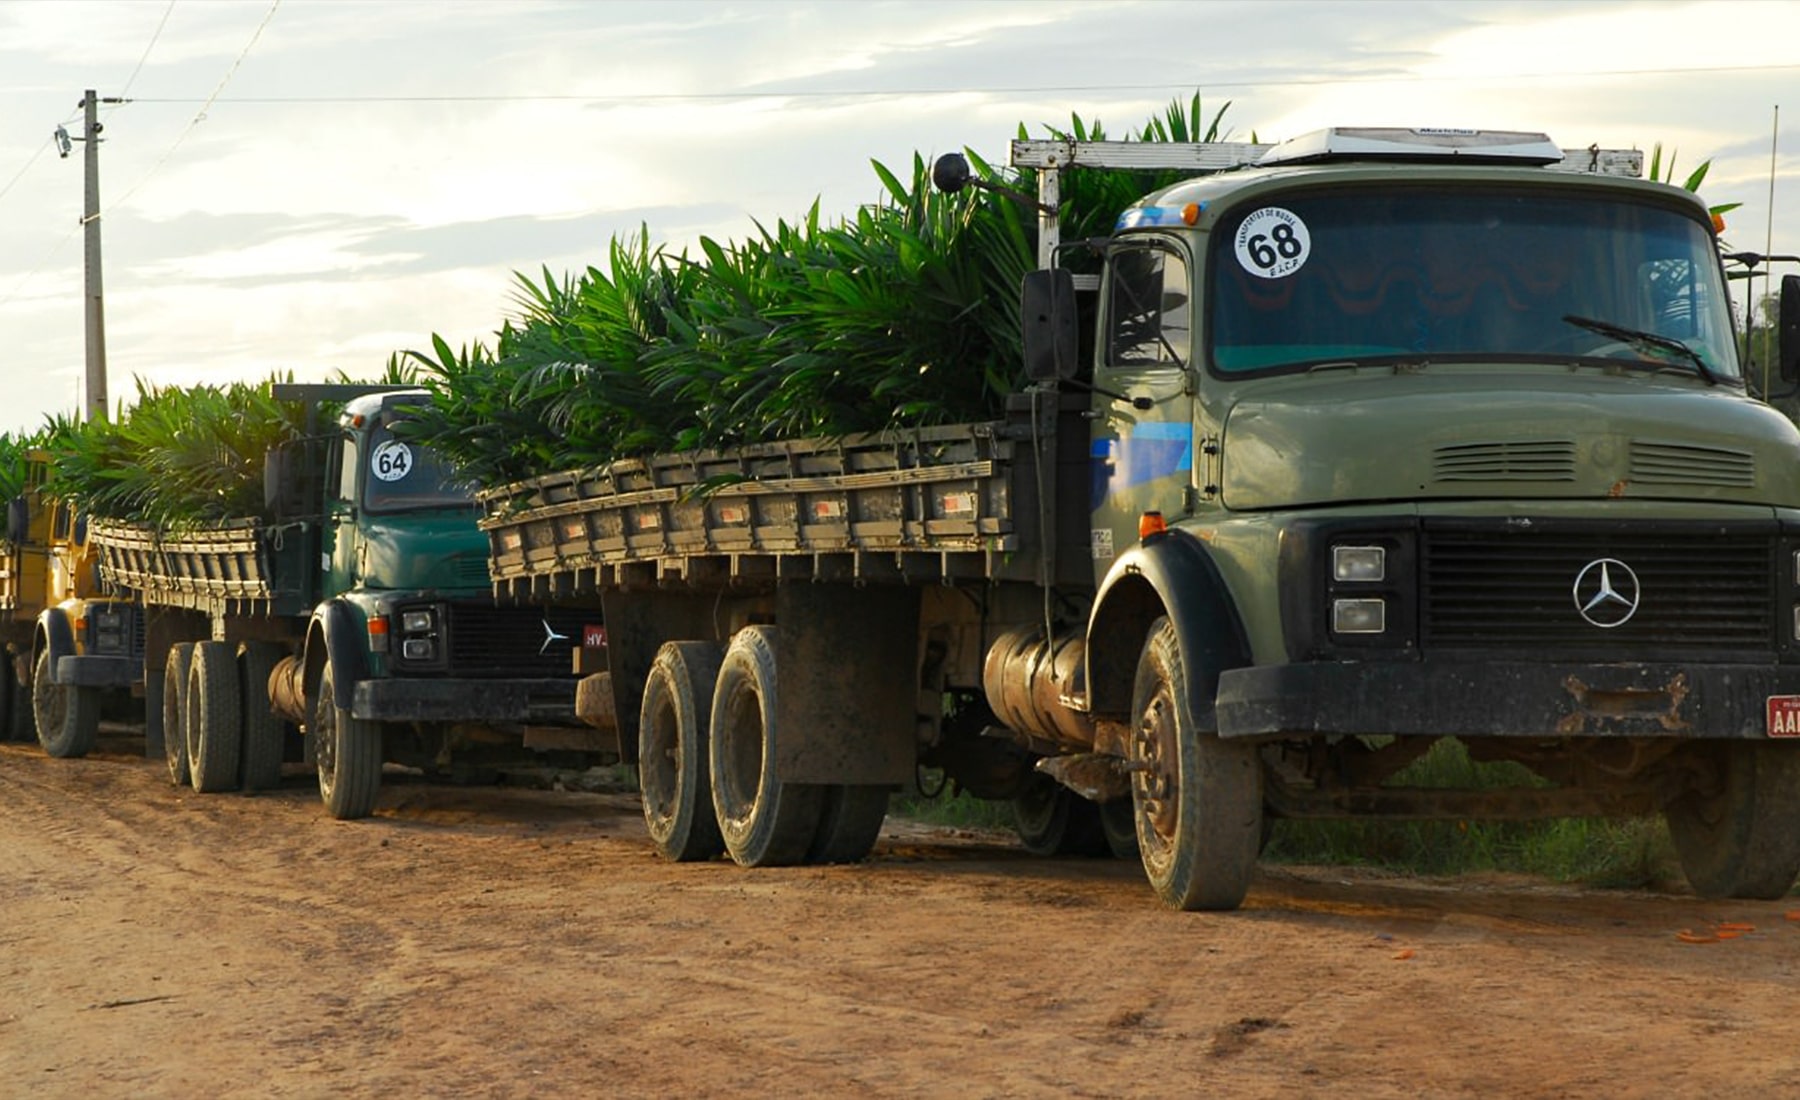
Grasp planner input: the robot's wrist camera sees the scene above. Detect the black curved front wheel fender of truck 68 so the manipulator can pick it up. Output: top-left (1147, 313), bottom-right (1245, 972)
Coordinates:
top-left (1087, 529), bottom-right (1249, 729)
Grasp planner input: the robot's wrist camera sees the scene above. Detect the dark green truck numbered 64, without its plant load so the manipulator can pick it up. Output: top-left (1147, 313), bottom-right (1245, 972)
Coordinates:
top-left (90, 385), bottom-right (597, 817)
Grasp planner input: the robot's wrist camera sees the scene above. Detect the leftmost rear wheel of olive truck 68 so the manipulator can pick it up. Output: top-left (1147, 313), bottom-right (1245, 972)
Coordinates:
top-left (637, 641), bottom-right (725, 862)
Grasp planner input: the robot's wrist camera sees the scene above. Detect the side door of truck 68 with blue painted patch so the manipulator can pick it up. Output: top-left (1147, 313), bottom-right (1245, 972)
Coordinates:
top-left (1089, 238), bottom-right (1193, 576)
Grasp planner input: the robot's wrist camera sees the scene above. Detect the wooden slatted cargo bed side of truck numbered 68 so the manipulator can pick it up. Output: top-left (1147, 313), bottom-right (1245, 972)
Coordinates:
top-left (481, 421), bottom-right (1037, 600)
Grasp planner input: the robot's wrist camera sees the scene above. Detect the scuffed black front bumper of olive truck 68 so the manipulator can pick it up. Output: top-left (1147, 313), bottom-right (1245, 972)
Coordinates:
top-left (1217, 661), bottom-right (1800, 740)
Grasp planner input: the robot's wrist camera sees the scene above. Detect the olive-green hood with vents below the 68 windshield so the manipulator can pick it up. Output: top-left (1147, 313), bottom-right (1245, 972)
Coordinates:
top-left (1220, 367), bottom-right (1800, 511)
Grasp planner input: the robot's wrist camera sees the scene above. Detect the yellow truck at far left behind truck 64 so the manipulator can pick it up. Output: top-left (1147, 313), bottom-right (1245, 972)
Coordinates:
top-left (0, 452), bottom-right (144, 756)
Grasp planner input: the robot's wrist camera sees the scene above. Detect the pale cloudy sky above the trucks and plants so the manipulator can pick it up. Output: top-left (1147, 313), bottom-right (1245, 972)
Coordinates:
top-left (0, 0), bottom-right (1800, 430)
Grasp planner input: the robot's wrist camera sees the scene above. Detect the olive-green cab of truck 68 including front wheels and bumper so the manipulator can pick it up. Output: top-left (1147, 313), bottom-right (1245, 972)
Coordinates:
top-left (1015, 130), bottom-right (1800, 907)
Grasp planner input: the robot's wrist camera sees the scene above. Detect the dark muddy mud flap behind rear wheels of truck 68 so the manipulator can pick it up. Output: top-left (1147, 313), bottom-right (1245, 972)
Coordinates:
top-left (774, 583), bottom-right (920, 785)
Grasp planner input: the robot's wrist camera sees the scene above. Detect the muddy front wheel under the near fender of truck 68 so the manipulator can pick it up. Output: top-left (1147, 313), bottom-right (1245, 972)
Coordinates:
top-left (1130, 618), bottom-right (1262, 909)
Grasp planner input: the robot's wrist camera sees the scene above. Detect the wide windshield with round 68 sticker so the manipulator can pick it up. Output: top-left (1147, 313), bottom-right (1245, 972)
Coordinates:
top-left (1206, 187), bottom-right (1739, 380)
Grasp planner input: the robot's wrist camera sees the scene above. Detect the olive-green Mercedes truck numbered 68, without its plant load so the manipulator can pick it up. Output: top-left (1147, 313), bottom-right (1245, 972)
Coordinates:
top-left (482, 130), bottom-right (1800, 909)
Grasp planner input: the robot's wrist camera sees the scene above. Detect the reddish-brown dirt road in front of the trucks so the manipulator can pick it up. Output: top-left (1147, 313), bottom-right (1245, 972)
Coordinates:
top-left (0, 745), bottom-right (1800, 1098)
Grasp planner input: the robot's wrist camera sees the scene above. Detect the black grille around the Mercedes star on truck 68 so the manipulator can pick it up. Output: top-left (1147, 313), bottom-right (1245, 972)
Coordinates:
top-left (1420, 524), bottom-right (1777, 659)
